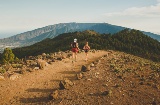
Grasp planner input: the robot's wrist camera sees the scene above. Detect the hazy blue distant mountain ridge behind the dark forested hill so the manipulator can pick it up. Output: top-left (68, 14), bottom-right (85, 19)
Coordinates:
top-left (0, 22), bottom-right (160, 49)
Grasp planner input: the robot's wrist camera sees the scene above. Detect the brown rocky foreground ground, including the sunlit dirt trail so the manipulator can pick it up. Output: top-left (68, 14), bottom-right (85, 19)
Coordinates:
top-left (0, 51), bottom-right (160, 105)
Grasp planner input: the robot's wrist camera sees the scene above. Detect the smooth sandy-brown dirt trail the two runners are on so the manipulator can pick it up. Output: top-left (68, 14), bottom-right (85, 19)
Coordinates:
top-left (0, 51), bottom-right (107, 105)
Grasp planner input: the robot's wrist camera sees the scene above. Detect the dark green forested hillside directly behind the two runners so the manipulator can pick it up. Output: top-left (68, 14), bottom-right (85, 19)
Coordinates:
top-left (13, 29), bottom-right (160, 61)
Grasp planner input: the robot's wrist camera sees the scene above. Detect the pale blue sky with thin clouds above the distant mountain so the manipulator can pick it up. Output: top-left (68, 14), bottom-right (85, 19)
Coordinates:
top-left (0, 0), bottom-right (160, 38)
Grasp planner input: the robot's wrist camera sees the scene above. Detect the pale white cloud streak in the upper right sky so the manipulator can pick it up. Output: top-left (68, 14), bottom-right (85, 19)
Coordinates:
top-left (104, 0), bottom-right (160, 17)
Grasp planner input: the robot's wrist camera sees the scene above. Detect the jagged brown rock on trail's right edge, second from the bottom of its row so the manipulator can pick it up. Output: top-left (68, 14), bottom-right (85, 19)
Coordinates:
top-left (59, 79), bottom-right (73, 89)
